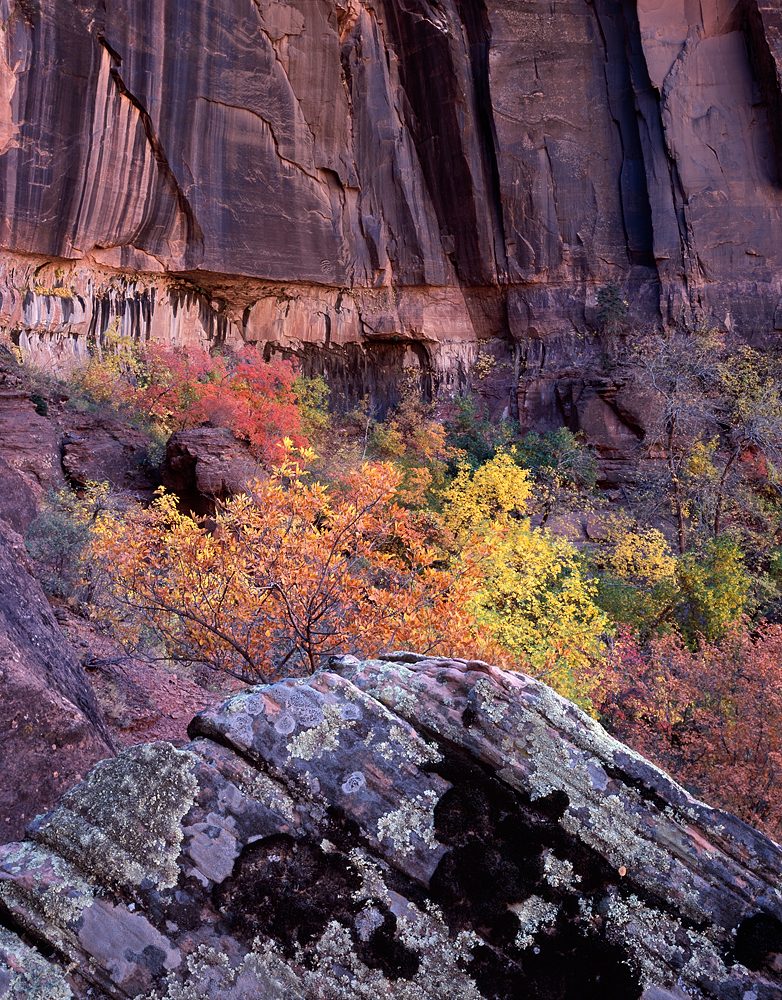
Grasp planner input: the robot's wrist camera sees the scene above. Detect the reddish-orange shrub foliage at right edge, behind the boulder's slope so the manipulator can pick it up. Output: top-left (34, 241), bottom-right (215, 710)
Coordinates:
top-left (597, 624), bottom-right (782, 838)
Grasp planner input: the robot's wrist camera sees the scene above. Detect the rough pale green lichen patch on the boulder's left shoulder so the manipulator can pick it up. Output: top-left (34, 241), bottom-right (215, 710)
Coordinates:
top-left (33, 743), bottom-right (198, 887)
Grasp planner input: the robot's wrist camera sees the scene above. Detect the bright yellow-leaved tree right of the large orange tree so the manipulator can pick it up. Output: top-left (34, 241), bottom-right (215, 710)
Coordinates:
top-left (444, 452), bottom-right (611, 707)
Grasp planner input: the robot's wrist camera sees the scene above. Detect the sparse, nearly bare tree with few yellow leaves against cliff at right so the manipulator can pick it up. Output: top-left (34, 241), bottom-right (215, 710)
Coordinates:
top-left (620, 330), bottom-right (782, 553)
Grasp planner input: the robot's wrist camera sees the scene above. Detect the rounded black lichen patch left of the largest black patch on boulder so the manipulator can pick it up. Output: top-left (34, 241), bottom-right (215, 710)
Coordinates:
top-left (214, 834), bottom-right (361, 955)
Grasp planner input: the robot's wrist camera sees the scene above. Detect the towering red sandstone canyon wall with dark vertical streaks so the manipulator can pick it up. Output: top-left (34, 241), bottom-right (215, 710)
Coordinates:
top-left (0, 0), bottom-right (782, 414)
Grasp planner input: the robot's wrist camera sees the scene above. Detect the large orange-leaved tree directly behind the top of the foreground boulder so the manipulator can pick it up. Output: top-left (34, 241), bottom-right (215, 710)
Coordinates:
top-left (90, 459), bottom-right (489, 681)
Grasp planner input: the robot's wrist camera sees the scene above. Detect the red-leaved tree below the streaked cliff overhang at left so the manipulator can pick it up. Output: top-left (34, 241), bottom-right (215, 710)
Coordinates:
top-left (81, 341), bottom-right (306, 463)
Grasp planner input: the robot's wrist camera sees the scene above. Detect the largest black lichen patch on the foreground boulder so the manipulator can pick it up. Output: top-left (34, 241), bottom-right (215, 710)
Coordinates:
top-left (429, 748), bottom-right (641, 1000)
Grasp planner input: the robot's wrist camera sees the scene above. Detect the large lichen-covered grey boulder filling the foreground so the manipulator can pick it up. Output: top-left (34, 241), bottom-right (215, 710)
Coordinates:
top-left (0, 653), bottom-right (782, 1000)
